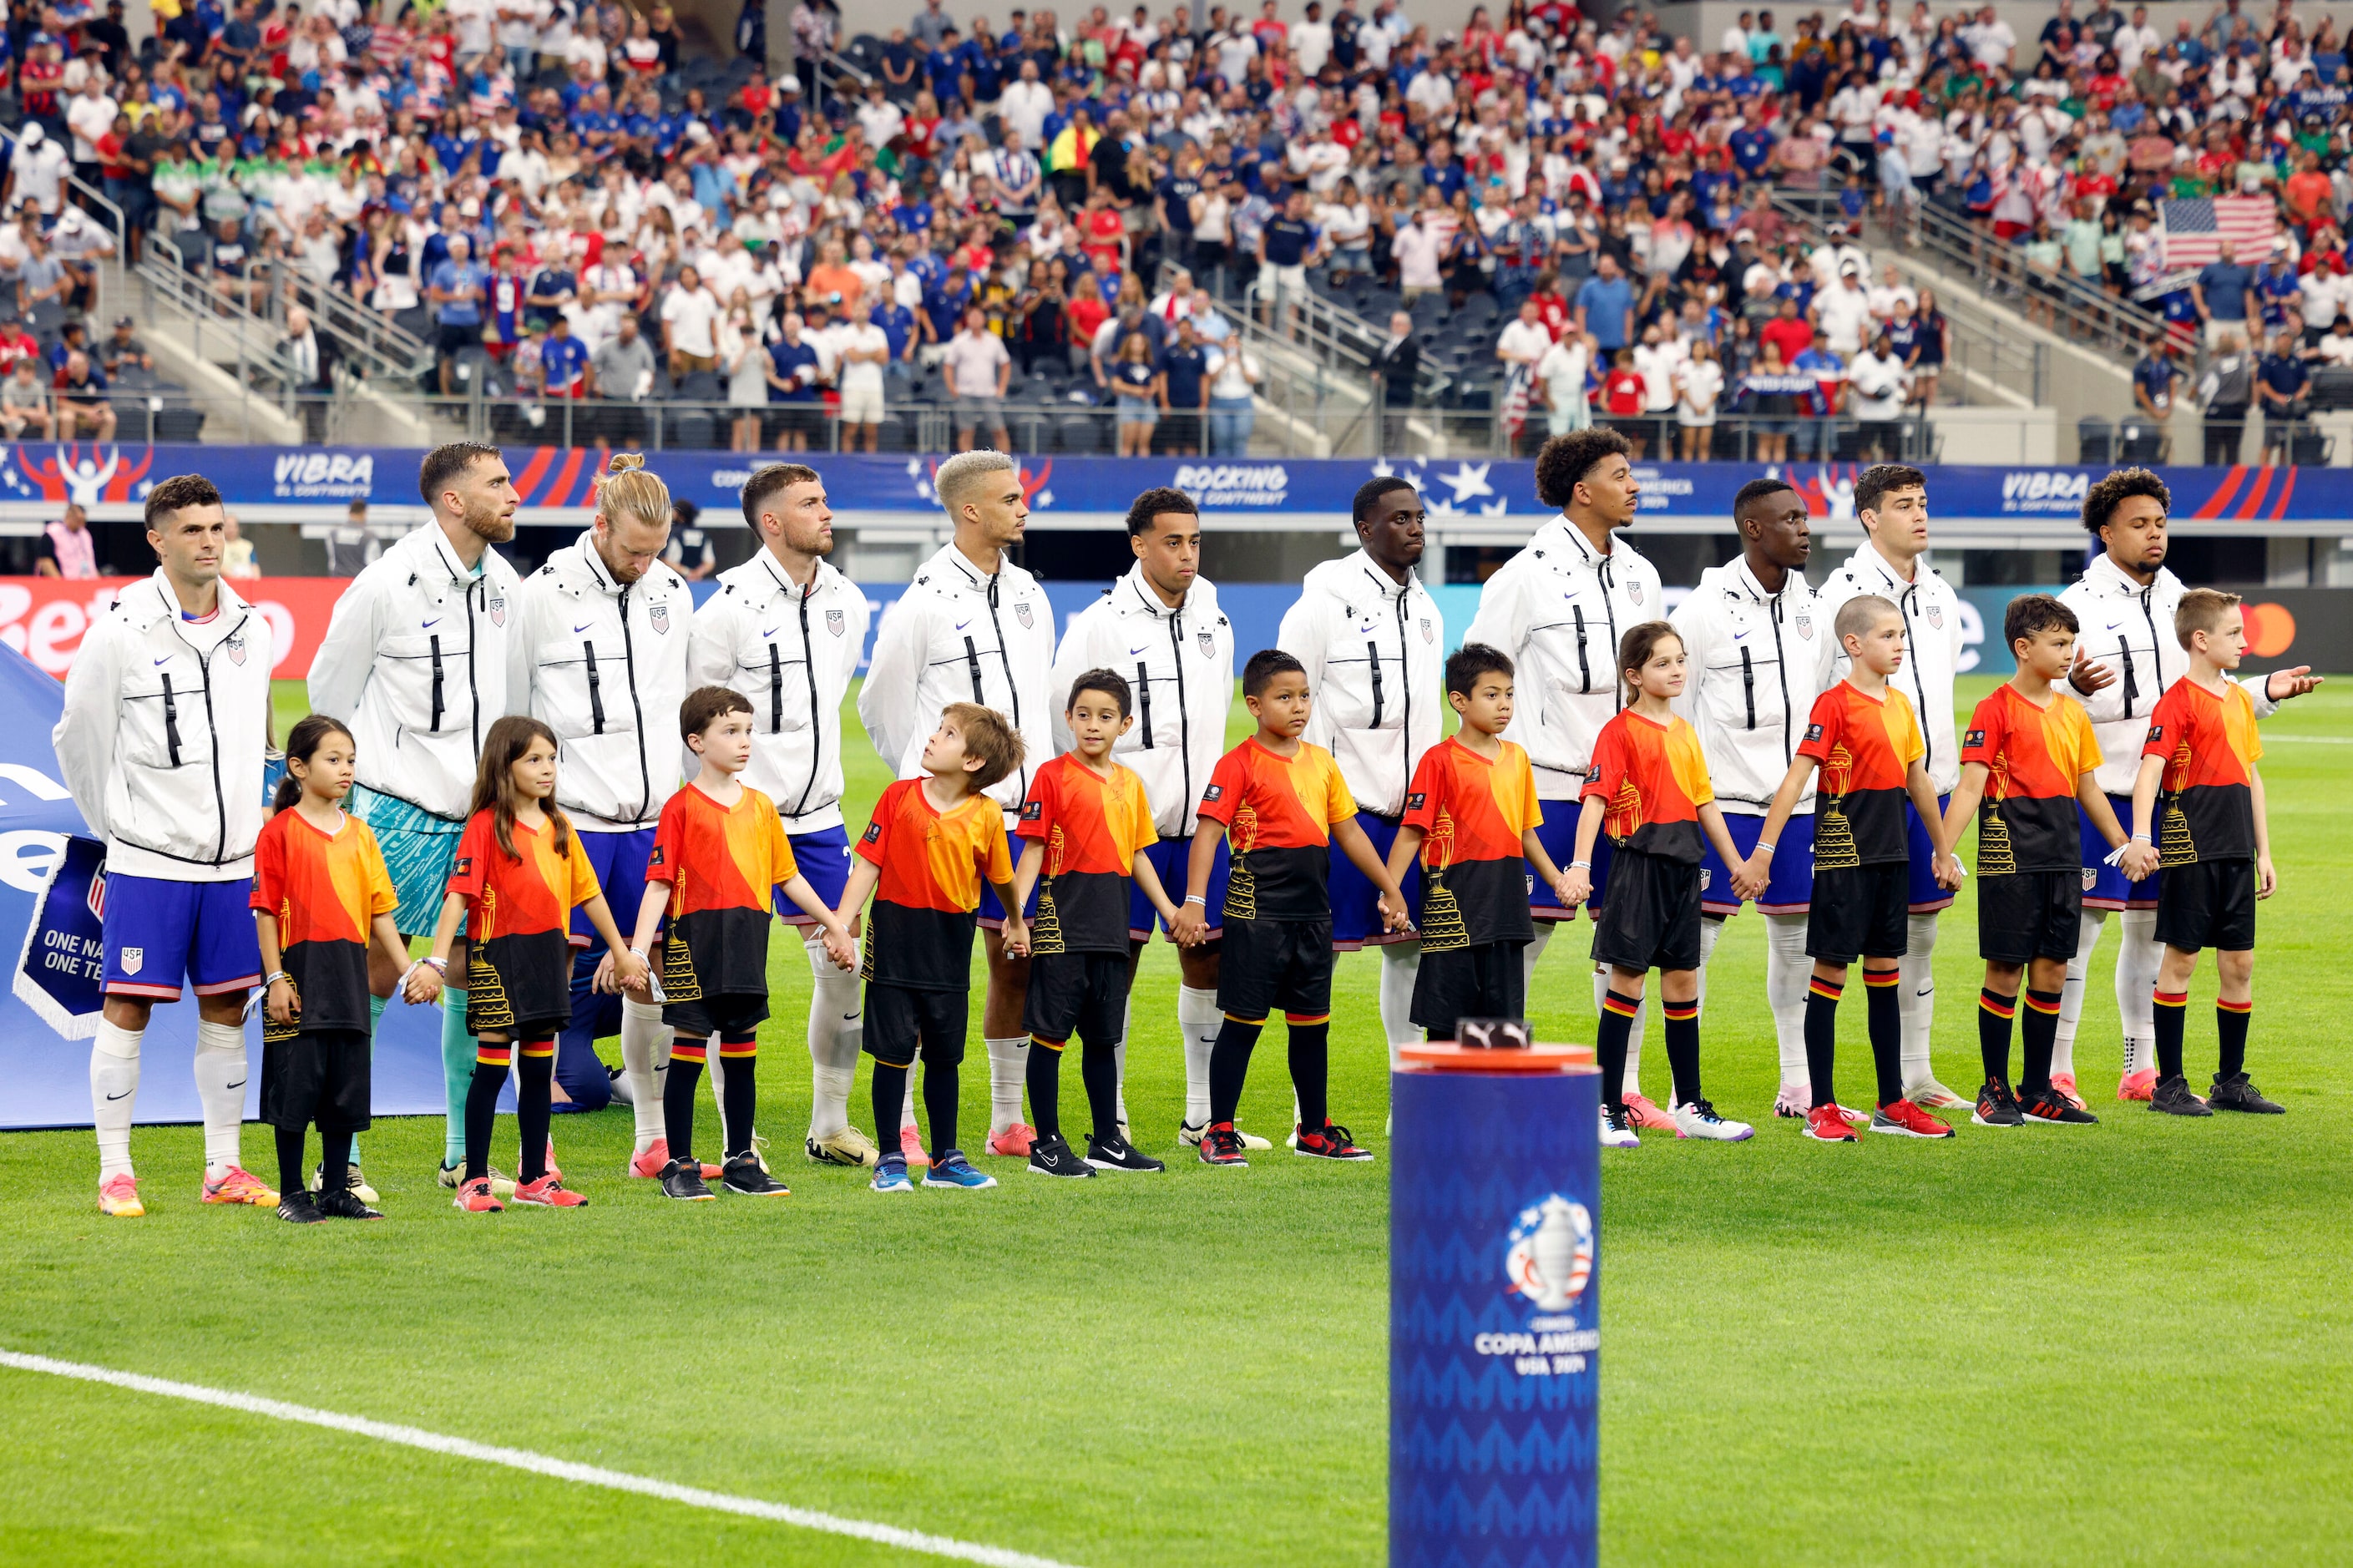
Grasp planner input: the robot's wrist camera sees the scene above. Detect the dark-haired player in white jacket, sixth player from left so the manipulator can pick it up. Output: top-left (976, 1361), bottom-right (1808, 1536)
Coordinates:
top-left (1047, 490), bottom-right (1266, 1149)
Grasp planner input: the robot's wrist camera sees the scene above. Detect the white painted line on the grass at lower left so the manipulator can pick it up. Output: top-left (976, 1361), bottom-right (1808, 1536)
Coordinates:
top-left (0, 1349), bottom-right (1070, 1568)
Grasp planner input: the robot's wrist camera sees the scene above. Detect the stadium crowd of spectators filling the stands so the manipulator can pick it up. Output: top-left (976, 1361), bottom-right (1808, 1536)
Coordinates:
top-left (0, 0), bottom-right (2353, 459)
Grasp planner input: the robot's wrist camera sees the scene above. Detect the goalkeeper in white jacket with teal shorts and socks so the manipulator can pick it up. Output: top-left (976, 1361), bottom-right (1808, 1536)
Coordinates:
top-left (311, 440), bottom-right (520, 1186)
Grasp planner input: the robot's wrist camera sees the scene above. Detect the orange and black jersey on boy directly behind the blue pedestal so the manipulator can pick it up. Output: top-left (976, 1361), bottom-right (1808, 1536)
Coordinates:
top-left (1404, 735), bottom-right (1544, 951)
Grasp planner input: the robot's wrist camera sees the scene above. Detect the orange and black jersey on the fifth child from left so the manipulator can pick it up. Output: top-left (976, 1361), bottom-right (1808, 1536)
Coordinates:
top-left (1015, 751), bottom-right (1160, 956)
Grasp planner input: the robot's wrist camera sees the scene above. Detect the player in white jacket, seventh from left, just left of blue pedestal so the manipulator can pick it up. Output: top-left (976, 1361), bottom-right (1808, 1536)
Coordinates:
top-left (1275, 478), bottom-right (1447, 1066)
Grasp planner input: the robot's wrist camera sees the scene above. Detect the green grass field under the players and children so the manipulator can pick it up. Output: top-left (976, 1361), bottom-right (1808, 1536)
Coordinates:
top-left (0, 680), bottom-right (2353, 1568)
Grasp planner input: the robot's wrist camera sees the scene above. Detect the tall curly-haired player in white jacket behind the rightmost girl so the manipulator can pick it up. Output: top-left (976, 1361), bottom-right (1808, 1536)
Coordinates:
top-left (1464, 428), bottom-right (1675, 1110)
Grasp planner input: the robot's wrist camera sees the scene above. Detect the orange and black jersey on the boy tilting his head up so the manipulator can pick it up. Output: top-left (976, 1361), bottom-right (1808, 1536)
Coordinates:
top-left (859, 779), bottom-right (1015, 991)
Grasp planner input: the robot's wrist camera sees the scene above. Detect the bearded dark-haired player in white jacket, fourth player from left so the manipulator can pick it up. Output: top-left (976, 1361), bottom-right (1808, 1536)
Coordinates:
top-left (691, 464), bottom-right (887, 1166)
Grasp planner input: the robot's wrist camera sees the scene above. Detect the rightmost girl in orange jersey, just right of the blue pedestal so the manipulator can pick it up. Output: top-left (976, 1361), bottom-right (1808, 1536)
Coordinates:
top-left (1560, 621), bottom-right (1763, 1149)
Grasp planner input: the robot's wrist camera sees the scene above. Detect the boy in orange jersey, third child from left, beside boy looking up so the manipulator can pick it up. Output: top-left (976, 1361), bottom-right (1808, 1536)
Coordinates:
top-left (607, 685), bottom-right (854, 1203)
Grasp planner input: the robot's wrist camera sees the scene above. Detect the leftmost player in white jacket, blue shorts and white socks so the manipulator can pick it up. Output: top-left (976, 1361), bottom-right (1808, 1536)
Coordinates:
top-left (49, 473), bottom-right (278, 1220)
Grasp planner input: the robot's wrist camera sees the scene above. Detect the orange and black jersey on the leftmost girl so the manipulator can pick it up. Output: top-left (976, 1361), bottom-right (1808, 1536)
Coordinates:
top-left (252, 807), bottom-right (400, 1040)
